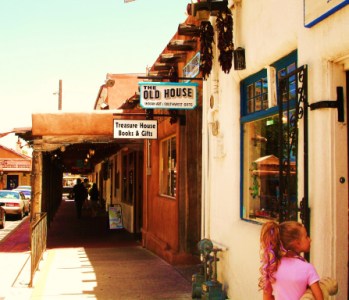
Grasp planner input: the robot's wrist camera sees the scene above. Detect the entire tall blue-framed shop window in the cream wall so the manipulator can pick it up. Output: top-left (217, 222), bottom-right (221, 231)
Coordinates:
top-left (241, 52), bottom-right (297, 222)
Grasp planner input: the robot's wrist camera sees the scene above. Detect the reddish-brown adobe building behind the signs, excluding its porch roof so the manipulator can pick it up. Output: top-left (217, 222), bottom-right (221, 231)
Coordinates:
top-left (89, 17), bottom-right (202, 264)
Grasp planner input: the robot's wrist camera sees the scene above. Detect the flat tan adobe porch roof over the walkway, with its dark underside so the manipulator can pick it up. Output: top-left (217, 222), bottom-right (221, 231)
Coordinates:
top-left (14, 110), bottom-right (143, 173)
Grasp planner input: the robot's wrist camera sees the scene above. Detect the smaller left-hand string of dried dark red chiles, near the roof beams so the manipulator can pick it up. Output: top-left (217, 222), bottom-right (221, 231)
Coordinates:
top-left (200, 21), bottom-right (214, 80)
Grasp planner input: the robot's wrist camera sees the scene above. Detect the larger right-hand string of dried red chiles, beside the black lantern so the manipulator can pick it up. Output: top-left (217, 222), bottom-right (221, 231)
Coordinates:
top-left (216, 8), bottom-right (234, 73)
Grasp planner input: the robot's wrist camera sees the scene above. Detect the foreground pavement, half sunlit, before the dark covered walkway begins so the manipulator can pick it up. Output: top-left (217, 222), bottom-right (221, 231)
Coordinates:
top-left (31, 246), bottom-right (191, 299)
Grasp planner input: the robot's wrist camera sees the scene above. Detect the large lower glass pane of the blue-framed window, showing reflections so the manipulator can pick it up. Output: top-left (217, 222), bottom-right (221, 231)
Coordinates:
top-left (243, 115), bottom-right (297, 221)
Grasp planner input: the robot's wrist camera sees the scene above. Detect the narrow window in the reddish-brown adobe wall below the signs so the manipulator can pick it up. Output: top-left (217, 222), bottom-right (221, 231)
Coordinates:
top-left (160, 136), bottom-right (177, 197)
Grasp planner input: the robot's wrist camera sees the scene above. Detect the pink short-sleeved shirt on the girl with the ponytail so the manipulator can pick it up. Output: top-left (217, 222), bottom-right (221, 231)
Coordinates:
top-left (272, 257), bottom-right (320, 300)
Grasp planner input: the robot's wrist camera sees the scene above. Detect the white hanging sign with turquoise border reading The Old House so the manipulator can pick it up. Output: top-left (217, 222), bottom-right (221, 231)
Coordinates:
top-left (139, 82), bottom-right (198, 109)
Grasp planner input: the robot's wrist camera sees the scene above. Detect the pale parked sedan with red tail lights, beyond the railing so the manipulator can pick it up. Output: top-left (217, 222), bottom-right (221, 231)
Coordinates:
top-left (0, 190), bottom-right (29, 219)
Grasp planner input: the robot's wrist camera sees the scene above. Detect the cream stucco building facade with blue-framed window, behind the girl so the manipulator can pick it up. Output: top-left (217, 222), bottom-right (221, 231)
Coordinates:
top-left (202, 0), bottom-right (349, 299)
